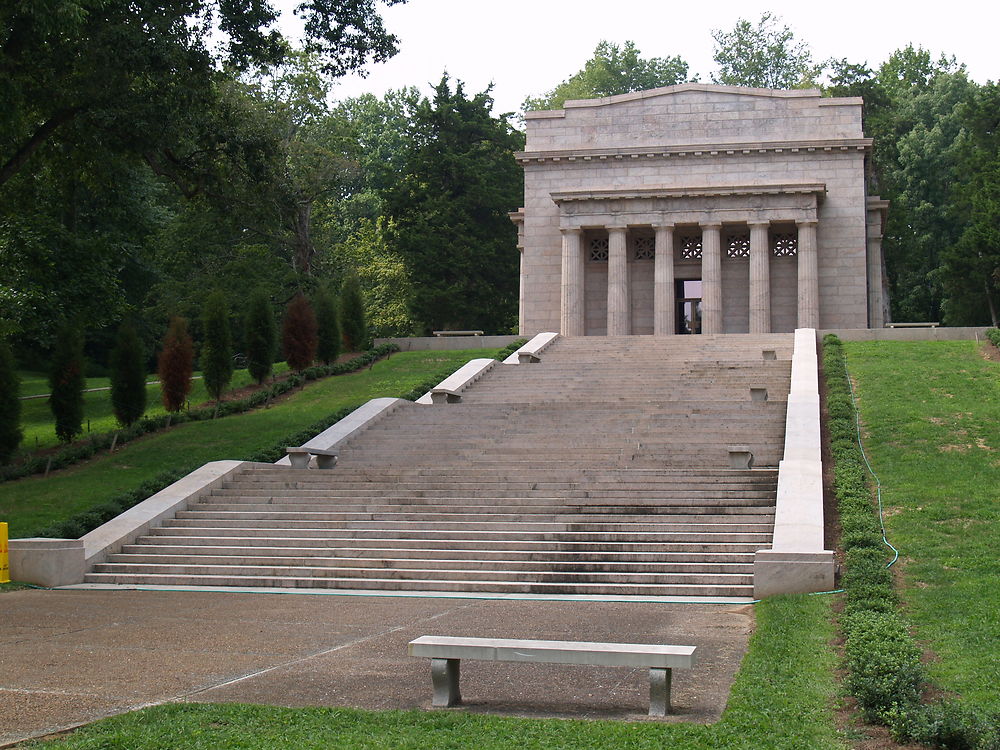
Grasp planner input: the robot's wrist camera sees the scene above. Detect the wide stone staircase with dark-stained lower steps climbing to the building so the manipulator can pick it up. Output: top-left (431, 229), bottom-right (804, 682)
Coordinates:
top-left (86, 334), bottom-right (792, 597)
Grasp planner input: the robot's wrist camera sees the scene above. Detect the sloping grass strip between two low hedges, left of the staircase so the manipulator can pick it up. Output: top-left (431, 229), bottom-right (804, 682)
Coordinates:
top-left (0, 349), bottom-right (483, 538)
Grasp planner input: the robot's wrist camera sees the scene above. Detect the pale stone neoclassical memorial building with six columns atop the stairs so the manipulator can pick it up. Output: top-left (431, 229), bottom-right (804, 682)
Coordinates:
top-left (511, 83), bottom-right (887, 336)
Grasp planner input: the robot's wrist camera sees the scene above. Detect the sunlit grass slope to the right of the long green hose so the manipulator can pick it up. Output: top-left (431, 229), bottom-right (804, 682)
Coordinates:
top-left (845, 341), bottom-right (1000, 710)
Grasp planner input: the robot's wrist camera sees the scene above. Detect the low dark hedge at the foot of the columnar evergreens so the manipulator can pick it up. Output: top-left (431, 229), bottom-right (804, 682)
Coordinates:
top-left (0, 344), bottom-right (399, 482)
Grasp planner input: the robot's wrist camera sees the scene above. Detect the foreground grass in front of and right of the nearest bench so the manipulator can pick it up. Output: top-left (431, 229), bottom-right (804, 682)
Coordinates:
top-left (25, 596), bottom-right (846, 750)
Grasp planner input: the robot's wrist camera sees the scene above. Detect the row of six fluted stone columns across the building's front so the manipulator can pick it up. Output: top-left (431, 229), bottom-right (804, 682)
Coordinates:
top-left (560, 219), bottom-right (819, 336)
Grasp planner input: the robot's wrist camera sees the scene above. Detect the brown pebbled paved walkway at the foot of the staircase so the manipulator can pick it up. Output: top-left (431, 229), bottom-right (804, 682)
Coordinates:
top-left (0, 590), bottom-right (753, 744)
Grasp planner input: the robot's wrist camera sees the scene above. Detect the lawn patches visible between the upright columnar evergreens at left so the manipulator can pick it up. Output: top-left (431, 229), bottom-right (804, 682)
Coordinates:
top-left (21, 362), bottom-right (288, 450)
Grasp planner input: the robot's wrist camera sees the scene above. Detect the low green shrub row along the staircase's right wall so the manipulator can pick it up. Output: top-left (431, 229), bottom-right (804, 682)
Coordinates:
top-left (823, 334), bottom-right (1000, 750)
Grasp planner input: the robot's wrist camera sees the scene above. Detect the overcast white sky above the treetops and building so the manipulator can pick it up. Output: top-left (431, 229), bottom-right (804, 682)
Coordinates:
top-left (275, 0), bottom-right (1000, 112)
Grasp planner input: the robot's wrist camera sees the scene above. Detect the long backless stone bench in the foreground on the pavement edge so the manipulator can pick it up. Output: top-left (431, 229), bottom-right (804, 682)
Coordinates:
top-left (407, 635), bottom-right (697, 716)
